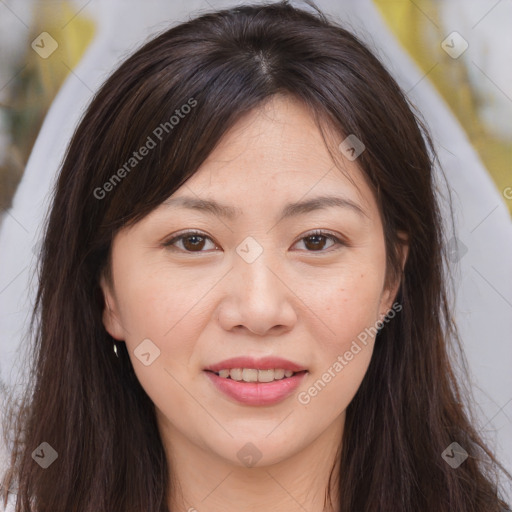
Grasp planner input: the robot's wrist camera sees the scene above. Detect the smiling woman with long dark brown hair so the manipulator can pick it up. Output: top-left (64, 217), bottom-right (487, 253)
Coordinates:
top-left (4, 2), bottom-right (510, 512)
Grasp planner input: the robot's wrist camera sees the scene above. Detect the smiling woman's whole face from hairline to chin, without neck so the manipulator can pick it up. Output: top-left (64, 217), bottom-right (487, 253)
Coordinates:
top-left (102, 97), bottom-right (404, 466)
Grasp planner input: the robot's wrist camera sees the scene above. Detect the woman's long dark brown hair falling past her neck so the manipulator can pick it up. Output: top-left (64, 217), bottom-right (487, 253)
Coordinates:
top-left (3, 2), bottom-right (510, 512)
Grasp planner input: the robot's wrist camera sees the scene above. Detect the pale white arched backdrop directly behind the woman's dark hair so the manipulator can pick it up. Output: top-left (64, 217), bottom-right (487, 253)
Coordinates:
top-left (0, 0), bottom-right (512, 500)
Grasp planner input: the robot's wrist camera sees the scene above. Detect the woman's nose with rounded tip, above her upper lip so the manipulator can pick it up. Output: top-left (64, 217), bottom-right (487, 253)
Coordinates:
top-left (218, 251), bottom-right (297, 336)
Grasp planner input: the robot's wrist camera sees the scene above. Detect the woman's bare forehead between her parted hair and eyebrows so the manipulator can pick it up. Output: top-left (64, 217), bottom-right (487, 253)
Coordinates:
top-left (168, 96), bottom-right (375, 213)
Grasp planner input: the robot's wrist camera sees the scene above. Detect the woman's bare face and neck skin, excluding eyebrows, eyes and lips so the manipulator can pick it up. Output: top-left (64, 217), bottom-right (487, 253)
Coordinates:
top-left (101, 96), bottom-right (405, 512)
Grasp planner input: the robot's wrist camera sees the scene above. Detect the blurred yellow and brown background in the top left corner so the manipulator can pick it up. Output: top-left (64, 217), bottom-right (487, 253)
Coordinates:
top-left (0, 0), bottom-right (96, 210)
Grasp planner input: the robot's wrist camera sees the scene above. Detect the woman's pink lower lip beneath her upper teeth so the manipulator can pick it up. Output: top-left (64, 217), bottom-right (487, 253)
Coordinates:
top-left (205, 371), bottom-right (307, 405)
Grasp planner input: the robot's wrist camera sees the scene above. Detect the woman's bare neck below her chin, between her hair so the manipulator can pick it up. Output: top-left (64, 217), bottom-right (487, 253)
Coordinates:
top-left (161, 414), bottom-right (344, 512)
